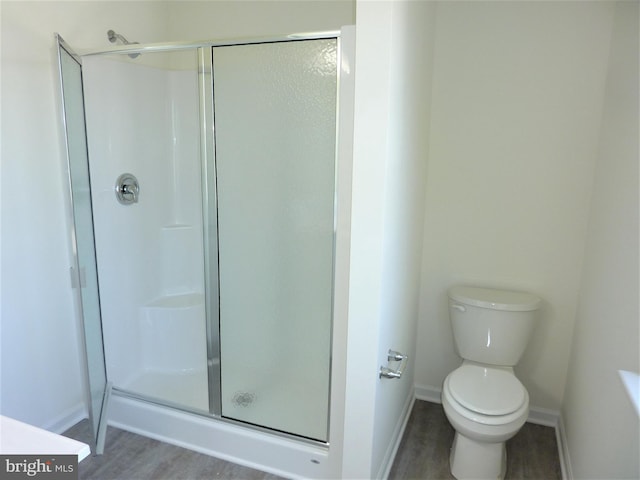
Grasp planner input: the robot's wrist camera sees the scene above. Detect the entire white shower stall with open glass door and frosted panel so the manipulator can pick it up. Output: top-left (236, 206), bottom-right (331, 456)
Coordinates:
top-left (58, 28), bottom-right (353, 478)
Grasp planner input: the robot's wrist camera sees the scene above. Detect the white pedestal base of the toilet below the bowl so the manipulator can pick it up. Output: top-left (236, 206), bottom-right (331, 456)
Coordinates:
top-left (449, 432), bottom-right (507, 480)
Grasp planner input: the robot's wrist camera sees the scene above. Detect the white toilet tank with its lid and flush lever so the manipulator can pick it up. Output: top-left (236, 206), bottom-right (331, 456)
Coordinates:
top-left (448, 286), bottom-right (542, 366)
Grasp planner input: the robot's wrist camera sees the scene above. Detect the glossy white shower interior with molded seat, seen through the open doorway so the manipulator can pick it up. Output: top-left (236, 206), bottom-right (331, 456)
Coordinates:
top-left (79, 49), bottom-right (210, 414)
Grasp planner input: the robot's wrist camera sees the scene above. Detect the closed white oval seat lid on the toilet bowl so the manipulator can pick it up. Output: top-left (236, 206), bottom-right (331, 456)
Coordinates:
top-left (447, 364), bottom-right (528, 416)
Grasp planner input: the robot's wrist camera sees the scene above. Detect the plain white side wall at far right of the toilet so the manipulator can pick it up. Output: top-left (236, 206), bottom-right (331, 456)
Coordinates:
top-left (562, 2), bottom-right (640, 479)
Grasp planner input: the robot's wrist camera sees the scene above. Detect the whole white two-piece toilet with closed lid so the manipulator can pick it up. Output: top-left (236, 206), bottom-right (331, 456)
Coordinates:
top-left (442, 286), bottom-right (542, 480)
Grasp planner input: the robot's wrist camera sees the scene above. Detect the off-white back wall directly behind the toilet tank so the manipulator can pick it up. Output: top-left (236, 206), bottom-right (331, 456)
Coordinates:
top-left (415, 2), bottom-right (613, 413)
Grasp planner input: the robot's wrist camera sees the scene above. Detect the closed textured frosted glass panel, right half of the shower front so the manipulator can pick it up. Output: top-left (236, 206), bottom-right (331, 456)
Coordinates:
top-left (213, 39), bottom-right (337, 441)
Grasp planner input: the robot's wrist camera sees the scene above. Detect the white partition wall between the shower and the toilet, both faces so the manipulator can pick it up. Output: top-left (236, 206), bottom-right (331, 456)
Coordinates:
top-left (342, 1), bottom-right (434, 478)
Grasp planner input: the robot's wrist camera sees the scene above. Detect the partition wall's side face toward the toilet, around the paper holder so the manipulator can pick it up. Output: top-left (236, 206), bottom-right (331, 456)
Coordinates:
top-left (370, 1), bottom-right (435, 478)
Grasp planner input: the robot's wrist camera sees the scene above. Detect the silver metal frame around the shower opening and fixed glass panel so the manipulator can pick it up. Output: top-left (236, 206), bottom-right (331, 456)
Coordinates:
top-left (80, 31), bottom-right (342, 446)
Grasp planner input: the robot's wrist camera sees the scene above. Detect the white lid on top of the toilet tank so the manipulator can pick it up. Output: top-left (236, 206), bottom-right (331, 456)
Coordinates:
top-left (449, 285), bottom-right (542, 312)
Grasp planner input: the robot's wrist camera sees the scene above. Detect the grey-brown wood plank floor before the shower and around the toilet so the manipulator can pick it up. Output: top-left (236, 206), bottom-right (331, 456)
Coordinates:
top-left (64, 401), bottom-right (562, 480)
